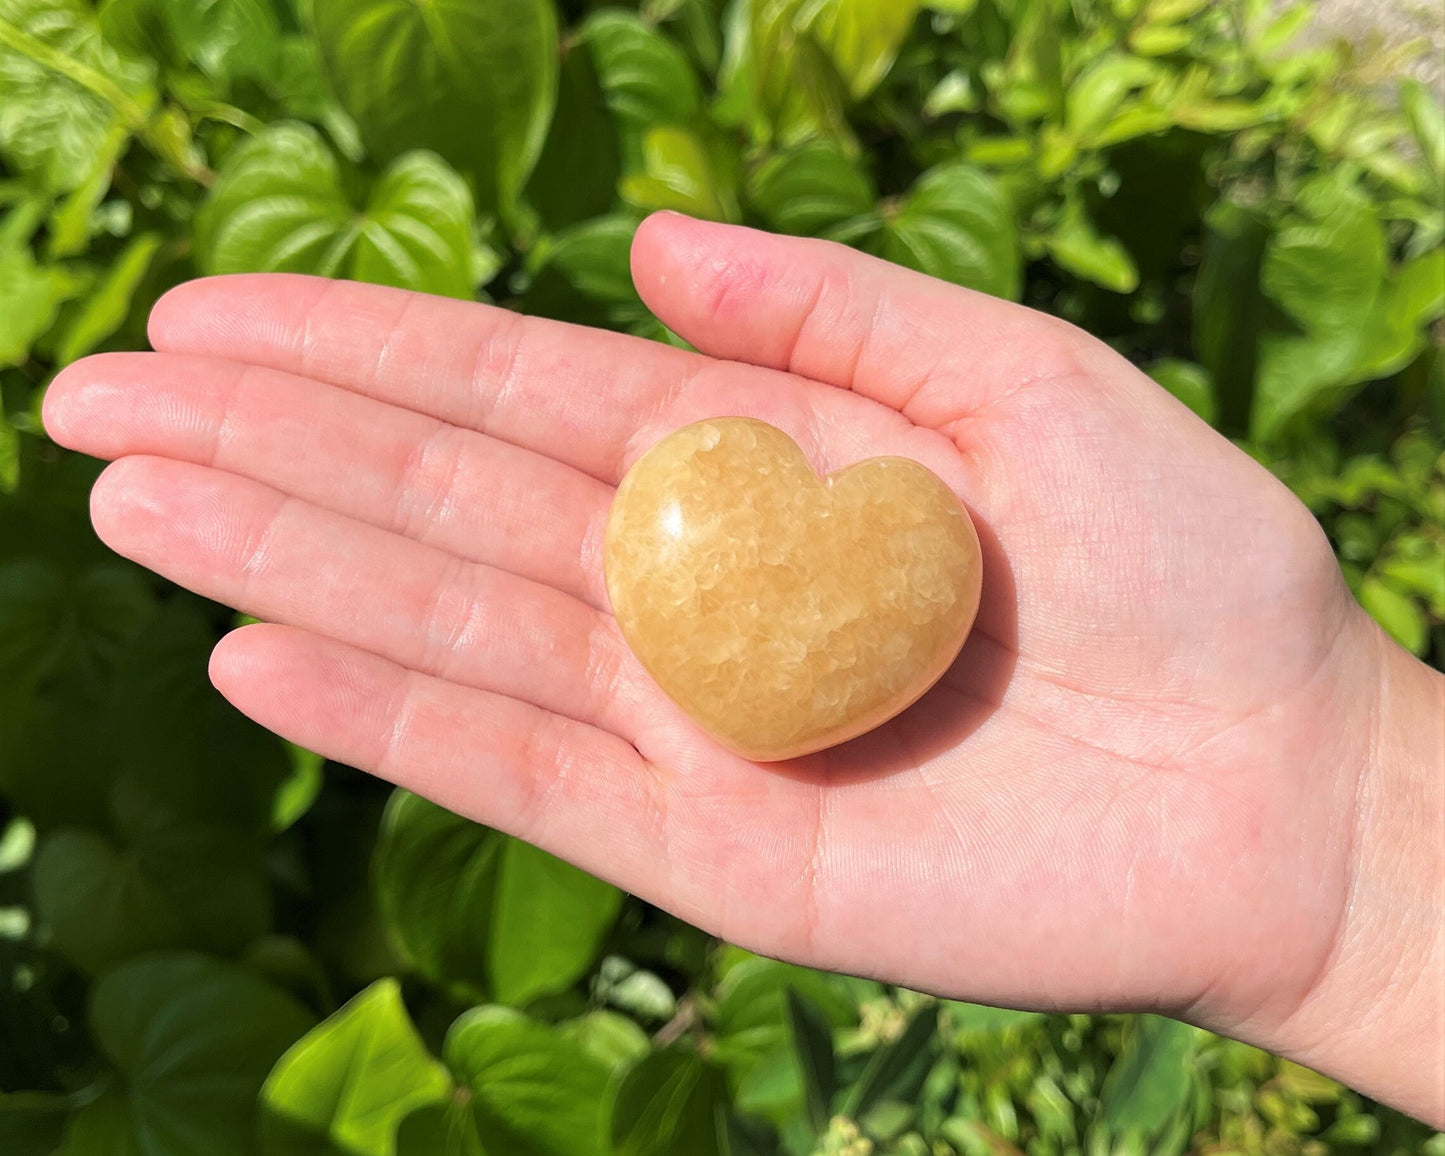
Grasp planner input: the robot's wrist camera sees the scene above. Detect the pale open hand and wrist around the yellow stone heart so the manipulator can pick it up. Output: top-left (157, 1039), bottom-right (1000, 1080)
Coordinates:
top-left (45, 214), bottom-right (1445, 1127)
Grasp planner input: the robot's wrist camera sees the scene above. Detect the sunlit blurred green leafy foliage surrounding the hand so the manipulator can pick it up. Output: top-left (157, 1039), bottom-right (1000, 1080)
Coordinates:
top-left (0, 0), bottom-right (1445, 1156)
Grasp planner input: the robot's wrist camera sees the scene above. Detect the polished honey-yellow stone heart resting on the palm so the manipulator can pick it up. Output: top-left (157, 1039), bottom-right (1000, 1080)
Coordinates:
top-left (604, 418), bottom-right (981, 762)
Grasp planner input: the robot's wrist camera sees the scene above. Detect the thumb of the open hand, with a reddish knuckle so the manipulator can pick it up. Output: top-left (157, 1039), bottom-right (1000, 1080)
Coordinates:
top-left (633, 212), bottom-right (1111, 429)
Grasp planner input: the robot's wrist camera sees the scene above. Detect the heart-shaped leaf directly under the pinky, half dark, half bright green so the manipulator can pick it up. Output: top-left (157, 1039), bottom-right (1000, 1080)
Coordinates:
top-left (376, 792), bottom-right (621, 1003)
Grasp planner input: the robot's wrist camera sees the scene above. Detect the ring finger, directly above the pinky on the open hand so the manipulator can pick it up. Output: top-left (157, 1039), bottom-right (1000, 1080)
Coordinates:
top-left (91, 457), bottom-right (643, 727)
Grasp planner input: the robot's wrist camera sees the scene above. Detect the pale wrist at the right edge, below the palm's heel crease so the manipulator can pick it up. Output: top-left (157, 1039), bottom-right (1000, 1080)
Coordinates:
top-left (1240, 613), bottom-right (1445, 1127)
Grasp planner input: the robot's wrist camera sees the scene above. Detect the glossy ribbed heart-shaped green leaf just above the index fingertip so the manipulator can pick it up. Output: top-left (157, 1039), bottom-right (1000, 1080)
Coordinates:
top-left (197, 124), bottom-right (474, 298)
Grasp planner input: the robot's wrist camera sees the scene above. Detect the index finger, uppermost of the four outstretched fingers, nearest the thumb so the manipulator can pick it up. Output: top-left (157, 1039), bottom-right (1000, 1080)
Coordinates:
top-left (150, 275), bottom-right (708, 483)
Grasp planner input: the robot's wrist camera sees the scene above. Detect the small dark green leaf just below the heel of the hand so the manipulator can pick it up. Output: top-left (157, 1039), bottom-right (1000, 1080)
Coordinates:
top-left (1100, 1016), bottom-right (1199, 1139)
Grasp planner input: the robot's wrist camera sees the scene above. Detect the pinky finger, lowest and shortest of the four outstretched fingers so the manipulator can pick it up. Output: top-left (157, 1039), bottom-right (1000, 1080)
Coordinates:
top-left (211, 624), bottom-right (662, 893)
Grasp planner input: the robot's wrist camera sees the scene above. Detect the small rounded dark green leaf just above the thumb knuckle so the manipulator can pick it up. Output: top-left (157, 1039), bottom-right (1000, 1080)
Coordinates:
top-left (749, 140), bottom-right (877, 237)
